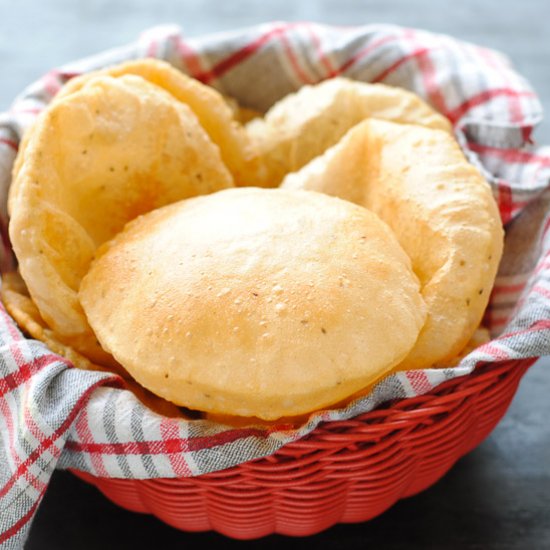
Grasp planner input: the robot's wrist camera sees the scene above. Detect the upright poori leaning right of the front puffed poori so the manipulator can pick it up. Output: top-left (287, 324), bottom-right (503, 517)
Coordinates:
top-left (282, 119), bottom-right (504, 369)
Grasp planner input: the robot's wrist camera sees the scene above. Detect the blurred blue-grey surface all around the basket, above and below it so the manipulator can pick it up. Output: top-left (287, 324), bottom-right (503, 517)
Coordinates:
top-left (0, 0), bottom-right (550, 550)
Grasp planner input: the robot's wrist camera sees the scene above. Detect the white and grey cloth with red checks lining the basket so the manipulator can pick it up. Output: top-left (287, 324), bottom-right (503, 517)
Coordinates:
top-left (0, 23), bottom-right (550, 548)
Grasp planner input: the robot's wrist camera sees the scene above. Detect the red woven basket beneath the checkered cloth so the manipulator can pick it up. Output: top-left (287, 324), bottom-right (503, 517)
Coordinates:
top-left (73, 359), bottom-right (535, 539)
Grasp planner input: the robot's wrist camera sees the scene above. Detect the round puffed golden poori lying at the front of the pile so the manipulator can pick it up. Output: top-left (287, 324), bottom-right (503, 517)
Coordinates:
top-left (79, 188), bottom-right (425, 420)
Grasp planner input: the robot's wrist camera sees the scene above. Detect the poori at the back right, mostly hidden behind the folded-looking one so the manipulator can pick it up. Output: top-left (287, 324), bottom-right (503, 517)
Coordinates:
top-left (247, 77), bottom-right (451, 187)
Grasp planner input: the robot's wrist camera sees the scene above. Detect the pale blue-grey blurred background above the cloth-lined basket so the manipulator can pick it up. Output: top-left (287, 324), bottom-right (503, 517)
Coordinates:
top-left (0, 0), bottom-right (550, 143)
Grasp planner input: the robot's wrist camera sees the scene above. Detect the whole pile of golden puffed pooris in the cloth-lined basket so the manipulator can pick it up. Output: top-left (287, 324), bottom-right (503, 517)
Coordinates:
top-left (2, 60), bottom-right (503, 423)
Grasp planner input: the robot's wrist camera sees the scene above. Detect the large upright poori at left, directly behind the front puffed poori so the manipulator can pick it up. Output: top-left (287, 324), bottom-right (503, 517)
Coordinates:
top-left (8, 75), bottom-right (233, 363)
